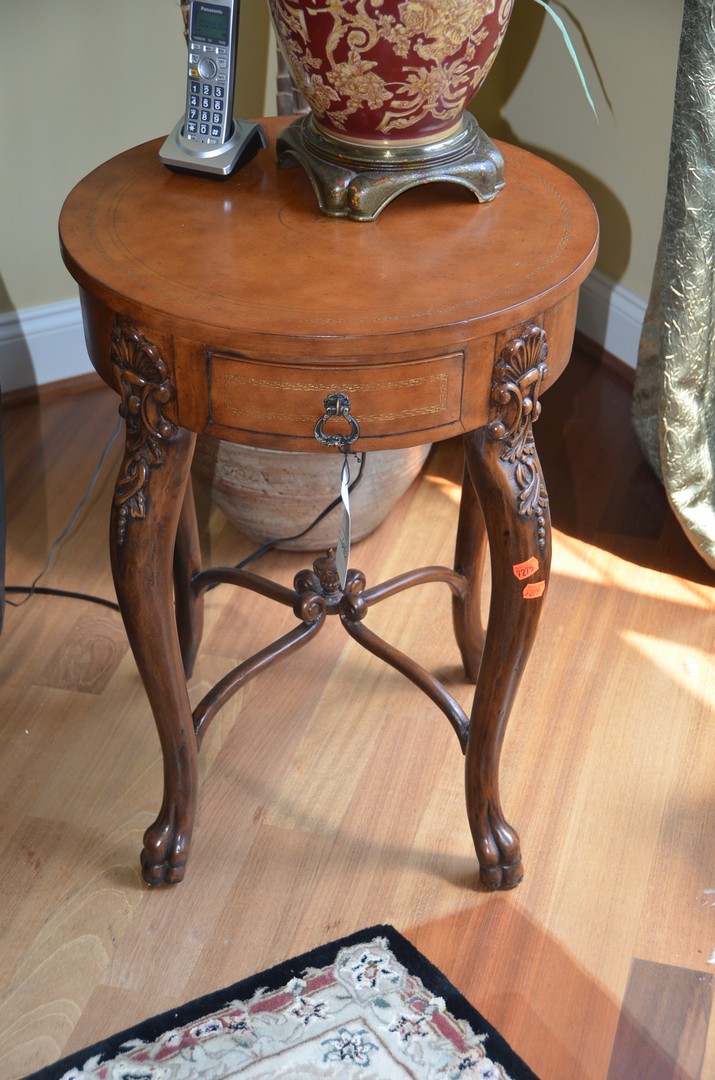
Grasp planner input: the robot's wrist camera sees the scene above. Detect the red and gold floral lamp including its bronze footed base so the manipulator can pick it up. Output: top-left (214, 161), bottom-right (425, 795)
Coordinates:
top-left (269, 0), bottom-right (513, 220)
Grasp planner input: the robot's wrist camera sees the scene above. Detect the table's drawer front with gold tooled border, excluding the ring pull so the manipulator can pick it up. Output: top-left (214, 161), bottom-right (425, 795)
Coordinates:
top-left (208, 352), bottom-right (464, 438)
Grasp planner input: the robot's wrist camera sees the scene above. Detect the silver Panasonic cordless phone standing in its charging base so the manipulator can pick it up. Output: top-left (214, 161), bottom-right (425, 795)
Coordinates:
top-left (159, 0), bottom-right (266, 179)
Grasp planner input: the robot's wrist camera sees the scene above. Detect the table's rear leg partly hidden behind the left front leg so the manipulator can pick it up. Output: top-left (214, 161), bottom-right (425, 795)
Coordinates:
top-left (174, 478), bottom-right (204, 678)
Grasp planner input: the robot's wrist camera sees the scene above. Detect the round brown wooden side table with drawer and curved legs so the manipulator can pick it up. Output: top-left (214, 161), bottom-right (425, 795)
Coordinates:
top-left (60, 119), bottom-right (598, 888)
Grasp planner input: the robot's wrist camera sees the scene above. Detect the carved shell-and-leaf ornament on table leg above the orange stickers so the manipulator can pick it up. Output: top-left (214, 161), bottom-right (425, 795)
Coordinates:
top-left (487, 325), bottom-right (549, 548)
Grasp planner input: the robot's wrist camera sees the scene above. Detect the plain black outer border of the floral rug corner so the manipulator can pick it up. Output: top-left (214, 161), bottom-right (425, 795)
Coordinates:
top-left (24, 923), bottom-right (539, 1080)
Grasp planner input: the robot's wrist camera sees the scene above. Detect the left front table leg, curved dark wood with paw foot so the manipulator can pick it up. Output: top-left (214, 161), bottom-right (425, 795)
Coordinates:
top-left (110, 327), bottom-right (199, 885)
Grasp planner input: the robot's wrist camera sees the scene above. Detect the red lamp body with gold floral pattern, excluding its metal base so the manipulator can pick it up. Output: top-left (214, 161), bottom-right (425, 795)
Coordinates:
top-left (269, 0), bottom-right (513, 144)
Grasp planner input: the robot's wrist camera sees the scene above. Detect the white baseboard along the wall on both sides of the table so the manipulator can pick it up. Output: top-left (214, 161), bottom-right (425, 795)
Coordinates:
top-left (0, 270), bottom-right (646, 392)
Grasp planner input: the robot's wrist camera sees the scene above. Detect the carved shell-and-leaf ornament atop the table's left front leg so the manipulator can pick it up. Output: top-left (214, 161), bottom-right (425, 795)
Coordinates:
top-left (111, 317), bottom-right (177, 544)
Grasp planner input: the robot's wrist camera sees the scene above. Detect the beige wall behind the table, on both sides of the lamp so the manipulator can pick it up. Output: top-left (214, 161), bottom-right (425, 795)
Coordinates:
top-left (0, 0), bottom-right (683, 312)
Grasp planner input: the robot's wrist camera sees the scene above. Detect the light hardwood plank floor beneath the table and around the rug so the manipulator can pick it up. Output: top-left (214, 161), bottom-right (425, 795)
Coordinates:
top-left (0, 355), bottom-right (715, 1080)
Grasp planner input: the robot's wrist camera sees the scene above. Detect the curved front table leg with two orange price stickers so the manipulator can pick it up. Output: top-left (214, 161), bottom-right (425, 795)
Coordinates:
top-left (464, 326), bottom-right (551, 889)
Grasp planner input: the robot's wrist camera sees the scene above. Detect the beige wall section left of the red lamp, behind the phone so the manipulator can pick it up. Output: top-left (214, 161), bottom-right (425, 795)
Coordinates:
top-left (0, 0), bottom-right (274, 312)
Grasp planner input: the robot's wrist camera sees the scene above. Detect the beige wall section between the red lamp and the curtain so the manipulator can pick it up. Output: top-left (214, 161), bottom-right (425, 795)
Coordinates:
top-left (472, 0), bottom-right (683, 298)
